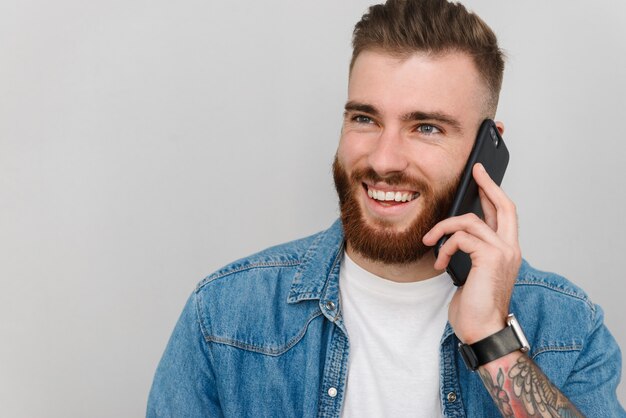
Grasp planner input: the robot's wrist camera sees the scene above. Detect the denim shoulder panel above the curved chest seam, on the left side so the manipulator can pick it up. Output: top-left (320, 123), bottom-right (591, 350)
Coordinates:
top-left (188, 224), bottom-right (339, 355)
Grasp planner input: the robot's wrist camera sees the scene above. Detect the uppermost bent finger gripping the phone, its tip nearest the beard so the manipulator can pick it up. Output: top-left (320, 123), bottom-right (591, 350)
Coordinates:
top-left (422, 213), bottom-right (502, 245)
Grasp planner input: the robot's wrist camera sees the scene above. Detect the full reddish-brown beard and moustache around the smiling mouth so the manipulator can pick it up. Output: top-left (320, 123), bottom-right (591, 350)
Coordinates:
top-left (333, 156), bottom-right (460, 264)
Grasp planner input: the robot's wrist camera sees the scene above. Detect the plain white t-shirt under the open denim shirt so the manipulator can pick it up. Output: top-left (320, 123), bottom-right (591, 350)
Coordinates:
top-left (339, 253), bottom-right (455, 418)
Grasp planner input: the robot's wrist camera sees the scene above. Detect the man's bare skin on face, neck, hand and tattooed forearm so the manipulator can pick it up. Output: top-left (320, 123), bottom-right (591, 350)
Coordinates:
top-left (337, 50), bottom-right (582, 417)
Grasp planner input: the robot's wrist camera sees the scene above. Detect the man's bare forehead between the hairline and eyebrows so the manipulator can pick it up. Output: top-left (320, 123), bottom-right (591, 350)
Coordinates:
top-left (348, 50), bottom-right (488, 123)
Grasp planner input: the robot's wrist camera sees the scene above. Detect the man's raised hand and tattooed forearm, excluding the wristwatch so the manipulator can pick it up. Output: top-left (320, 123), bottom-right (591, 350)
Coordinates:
top-left (423, 164), bottom-right (582, 417)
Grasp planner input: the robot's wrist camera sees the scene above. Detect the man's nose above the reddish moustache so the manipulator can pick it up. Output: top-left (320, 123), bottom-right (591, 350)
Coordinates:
top-left (368, 127), bottom-right (408, 177)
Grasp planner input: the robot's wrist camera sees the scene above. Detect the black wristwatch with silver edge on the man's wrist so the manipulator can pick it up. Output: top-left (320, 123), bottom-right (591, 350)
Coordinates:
top-left (459, 314), bottom-right (530, 371)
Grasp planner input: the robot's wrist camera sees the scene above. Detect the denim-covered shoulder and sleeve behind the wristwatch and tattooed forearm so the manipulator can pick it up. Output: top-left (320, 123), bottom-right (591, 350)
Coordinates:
top-left (511, 261), bottom-right (621, 410)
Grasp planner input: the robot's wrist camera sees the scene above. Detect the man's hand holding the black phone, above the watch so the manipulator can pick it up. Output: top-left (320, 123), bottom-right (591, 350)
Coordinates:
top-left (423, 164), bottom-right (522, 344)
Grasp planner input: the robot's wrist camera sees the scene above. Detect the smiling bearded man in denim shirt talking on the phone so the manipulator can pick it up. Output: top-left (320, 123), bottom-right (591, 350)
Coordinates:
top-left (148, 0), bottom-right (626, 417)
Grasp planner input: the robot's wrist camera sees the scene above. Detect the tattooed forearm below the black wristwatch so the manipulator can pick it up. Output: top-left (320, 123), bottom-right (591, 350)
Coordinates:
top-left (479, 355), bottom-right (584, 418)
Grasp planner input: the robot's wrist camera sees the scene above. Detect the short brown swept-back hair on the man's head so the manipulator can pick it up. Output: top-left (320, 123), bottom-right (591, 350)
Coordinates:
top-left (350, 0), bottom-right (504, 117)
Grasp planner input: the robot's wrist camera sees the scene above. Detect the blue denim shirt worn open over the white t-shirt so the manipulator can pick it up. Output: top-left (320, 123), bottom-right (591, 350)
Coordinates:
top-left (147, 221), bottom-right (626, 418)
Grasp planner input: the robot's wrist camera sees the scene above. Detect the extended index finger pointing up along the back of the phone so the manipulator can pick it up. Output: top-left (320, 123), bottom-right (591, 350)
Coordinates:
top-left (472, 163), bottom-right (517, 244)
